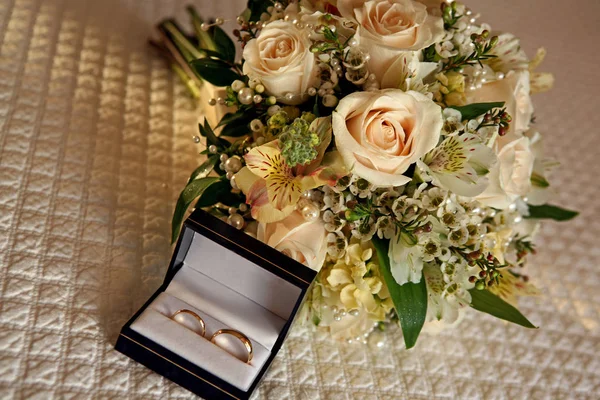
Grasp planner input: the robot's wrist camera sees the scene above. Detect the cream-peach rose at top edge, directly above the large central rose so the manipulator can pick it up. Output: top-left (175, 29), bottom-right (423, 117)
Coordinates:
top-left (337, 0), bottom-right (444, 88)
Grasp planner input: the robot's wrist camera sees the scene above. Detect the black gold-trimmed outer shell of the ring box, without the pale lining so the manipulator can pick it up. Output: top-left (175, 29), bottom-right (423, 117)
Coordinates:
top-left (115, 209), bottom-right (317, 400)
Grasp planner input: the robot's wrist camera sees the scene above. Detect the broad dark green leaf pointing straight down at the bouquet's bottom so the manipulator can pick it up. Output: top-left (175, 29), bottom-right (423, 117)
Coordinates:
top-left (373, 238), bottom-right (427, 349)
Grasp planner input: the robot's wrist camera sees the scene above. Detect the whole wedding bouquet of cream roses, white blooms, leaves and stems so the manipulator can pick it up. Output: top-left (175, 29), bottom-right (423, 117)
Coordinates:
top-left (154, 0), bottom-right (576, 348)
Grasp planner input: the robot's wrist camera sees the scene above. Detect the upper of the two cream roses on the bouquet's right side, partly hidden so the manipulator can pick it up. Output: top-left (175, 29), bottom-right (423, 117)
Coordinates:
top-left (466, 71), bottom-right (533, 148)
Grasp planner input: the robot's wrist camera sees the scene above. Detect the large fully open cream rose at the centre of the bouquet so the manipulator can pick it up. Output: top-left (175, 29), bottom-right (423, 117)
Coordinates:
top-left (333, 89), bottom-right (443, 186)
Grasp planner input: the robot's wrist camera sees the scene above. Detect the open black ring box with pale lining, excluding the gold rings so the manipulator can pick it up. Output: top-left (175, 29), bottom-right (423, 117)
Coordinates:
top-left (115, 210), bottom-right (316, 399)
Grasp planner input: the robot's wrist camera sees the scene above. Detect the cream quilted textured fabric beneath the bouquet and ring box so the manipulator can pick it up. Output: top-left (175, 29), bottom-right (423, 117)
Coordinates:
top-left (0, 0), bottom-right (600, 399)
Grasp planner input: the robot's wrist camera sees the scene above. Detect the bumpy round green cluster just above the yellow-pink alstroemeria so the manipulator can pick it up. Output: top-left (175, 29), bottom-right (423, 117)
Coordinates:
top-left (279, 118), bottom-right (320, 168)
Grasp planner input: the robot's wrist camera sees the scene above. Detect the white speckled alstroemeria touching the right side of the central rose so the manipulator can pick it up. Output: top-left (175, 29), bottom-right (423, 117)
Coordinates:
top-left (417, 134), bottom-right (496, 197)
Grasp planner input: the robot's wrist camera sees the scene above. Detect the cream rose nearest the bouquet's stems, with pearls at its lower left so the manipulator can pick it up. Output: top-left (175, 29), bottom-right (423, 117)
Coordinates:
top-left (243, 21), bottom-right (319, 105)
